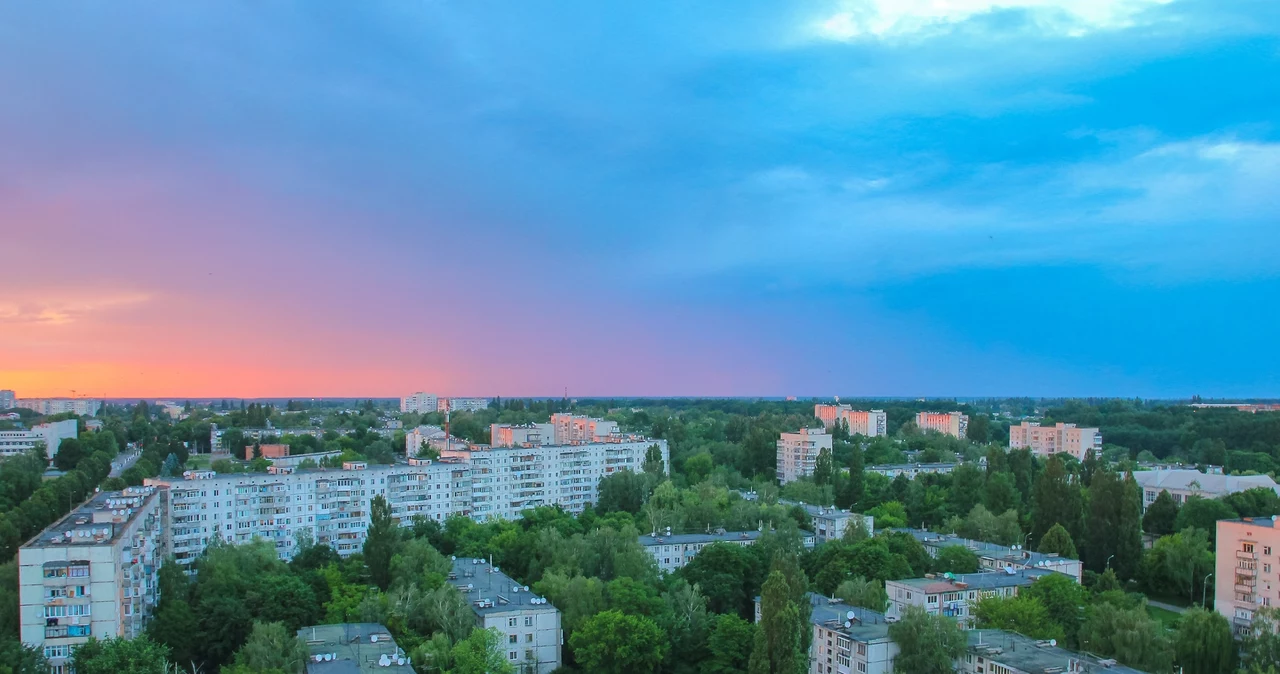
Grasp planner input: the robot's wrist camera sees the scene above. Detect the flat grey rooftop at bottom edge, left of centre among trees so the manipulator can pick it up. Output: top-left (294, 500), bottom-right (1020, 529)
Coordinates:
top-left (298, 623), bottom-right (413, 674)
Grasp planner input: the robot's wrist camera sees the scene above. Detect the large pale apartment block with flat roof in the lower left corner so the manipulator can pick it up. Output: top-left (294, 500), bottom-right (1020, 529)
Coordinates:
top-left (18, 487), bottom-right (165, 674)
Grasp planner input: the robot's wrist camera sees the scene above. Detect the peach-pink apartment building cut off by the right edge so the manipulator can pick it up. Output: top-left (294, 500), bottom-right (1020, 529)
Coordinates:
top-left (1213, 517), bottom-right (1280, 636)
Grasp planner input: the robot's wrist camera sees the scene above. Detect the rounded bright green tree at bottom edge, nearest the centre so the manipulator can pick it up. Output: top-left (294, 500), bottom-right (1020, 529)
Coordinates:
top-left (570, 610), bottom-right (667, 674)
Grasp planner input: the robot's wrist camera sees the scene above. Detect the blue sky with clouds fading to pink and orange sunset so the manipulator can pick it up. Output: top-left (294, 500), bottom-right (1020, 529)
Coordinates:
top-left (0, 0), bottom-right (1280, 398)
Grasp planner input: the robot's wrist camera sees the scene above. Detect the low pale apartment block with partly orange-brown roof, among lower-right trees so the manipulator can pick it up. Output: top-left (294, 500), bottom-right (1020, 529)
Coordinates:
top-left (884, 568), bottom-right (1053, 628)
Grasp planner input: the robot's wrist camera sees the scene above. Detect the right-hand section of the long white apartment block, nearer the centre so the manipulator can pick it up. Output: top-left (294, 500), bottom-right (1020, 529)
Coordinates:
top-left (440, 435), bottom-right (671, 521)
